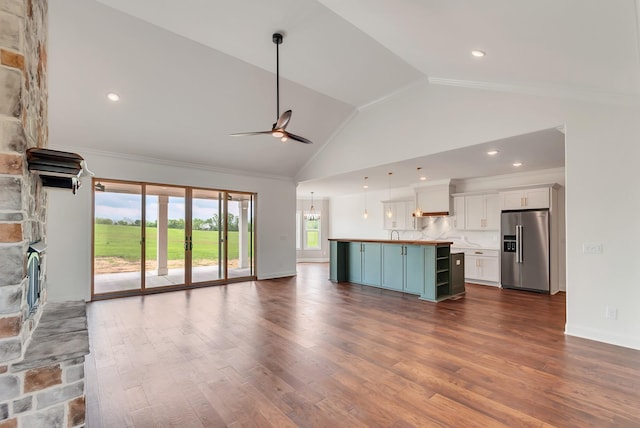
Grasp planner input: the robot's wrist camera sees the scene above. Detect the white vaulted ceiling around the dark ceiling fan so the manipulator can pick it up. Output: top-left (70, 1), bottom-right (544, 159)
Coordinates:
top-left (49, 0), bottom-right (640, 194)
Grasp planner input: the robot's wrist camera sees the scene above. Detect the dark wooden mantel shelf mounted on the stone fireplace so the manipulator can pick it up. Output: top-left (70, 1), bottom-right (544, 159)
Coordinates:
top-left (27, 147), bottom-right (93, 194)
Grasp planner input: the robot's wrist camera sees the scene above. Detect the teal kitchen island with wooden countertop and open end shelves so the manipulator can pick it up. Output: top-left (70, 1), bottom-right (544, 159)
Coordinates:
top-left (329, 239), bottom-right (464, 302)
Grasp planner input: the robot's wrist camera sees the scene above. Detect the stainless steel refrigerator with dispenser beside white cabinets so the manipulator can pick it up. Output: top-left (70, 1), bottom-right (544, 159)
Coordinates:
top-left (500, 210), bottom-right (550, 293)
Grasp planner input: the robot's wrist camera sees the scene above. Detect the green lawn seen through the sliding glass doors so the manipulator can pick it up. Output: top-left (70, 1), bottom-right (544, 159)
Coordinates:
top-left (94, 224), bottom-right (238, 261)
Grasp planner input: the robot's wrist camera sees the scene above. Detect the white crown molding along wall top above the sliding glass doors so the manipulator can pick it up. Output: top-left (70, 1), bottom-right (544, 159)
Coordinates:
top-left (48, 145), bottom-right (294, 182)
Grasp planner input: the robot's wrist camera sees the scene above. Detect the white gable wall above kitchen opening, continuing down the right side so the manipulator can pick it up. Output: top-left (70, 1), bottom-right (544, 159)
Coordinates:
top-left (298, 84), bottom-right (640, 349)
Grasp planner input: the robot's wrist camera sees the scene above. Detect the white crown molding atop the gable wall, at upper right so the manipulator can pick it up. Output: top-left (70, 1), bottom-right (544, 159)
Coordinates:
top-left (429, 75), bottom-right (640, 106)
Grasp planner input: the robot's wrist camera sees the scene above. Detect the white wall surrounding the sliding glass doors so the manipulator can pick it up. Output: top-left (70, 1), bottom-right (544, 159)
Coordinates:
top-left (47, 147), bottom-right (296, 301)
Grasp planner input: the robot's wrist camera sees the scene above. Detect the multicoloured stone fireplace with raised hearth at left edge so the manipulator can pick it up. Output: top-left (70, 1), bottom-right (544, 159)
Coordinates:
top-left (0, 0), bottom-right (88, 428)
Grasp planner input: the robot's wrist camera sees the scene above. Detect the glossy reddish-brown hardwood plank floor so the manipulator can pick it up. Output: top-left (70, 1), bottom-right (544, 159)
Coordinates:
top-left (86, 264), bottom-right (640, 428)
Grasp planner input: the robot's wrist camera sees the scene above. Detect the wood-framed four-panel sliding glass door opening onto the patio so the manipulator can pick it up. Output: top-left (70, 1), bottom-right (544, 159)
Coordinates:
top-left (92, 179), bottom-right (255, 298)
